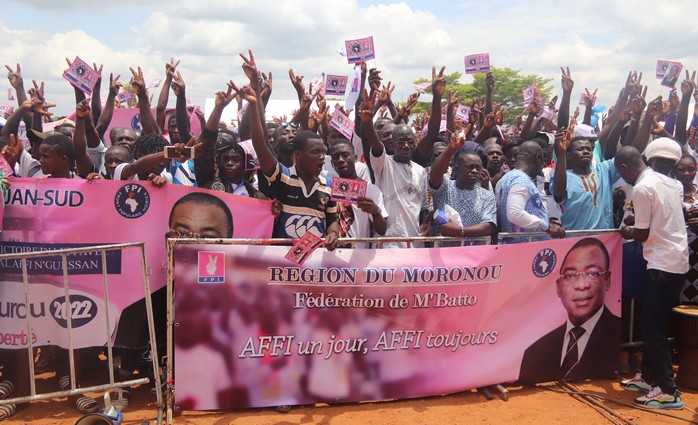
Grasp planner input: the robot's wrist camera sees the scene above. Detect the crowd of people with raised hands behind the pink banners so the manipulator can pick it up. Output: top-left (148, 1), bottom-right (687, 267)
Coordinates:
top-left (0, 52), bottom-right (698, 420)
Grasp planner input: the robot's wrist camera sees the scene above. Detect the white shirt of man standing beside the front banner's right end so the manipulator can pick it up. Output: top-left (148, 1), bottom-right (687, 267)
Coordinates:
top-left (632, 167), bottom-right (689, 274)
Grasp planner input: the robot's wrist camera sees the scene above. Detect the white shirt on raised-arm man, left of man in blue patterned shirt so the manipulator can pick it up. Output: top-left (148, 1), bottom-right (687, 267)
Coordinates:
top-left (369, 149), bottom-right (431, 248)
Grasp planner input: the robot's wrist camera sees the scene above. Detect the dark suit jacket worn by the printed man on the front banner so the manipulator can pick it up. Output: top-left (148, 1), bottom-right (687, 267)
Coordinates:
top-left (519, 306), bottom-right (620, 383)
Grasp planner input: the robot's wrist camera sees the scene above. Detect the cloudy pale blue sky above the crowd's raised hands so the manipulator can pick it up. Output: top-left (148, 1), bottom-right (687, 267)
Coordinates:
top-left (0, 0), bottom-right (698, 114)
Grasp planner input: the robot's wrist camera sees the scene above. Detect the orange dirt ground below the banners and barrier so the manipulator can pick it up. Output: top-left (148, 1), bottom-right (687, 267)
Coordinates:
top-left (5, 378), bottom-right (698, 425)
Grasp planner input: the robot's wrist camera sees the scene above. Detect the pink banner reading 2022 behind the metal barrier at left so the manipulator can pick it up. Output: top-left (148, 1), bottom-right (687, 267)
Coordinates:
top-left (0, 179), bottom-right (273, 348)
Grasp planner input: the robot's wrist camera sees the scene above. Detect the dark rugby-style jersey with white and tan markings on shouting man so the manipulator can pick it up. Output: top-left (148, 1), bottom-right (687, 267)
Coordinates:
top-left (266, 162), bottom-right (337, 239)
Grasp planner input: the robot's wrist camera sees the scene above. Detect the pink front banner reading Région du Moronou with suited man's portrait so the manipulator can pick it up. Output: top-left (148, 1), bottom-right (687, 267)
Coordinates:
top-left (174, 235), bottom-right (622, 410)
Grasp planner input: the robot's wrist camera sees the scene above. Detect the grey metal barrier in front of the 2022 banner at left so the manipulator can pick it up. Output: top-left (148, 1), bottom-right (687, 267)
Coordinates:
top-left (0, 242), bottom-right (164, 424)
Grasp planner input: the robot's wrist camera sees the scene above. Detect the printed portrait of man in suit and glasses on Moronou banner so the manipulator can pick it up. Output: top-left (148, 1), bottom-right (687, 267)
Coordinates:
top-left (519, 237), bottom-right (620, 382)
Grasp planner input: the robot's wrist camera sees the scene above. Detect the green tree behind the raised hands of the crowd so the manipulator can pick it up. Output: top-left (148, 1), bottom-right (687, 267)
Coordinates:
top-left (412, 67), bottom-right (553, 123)
